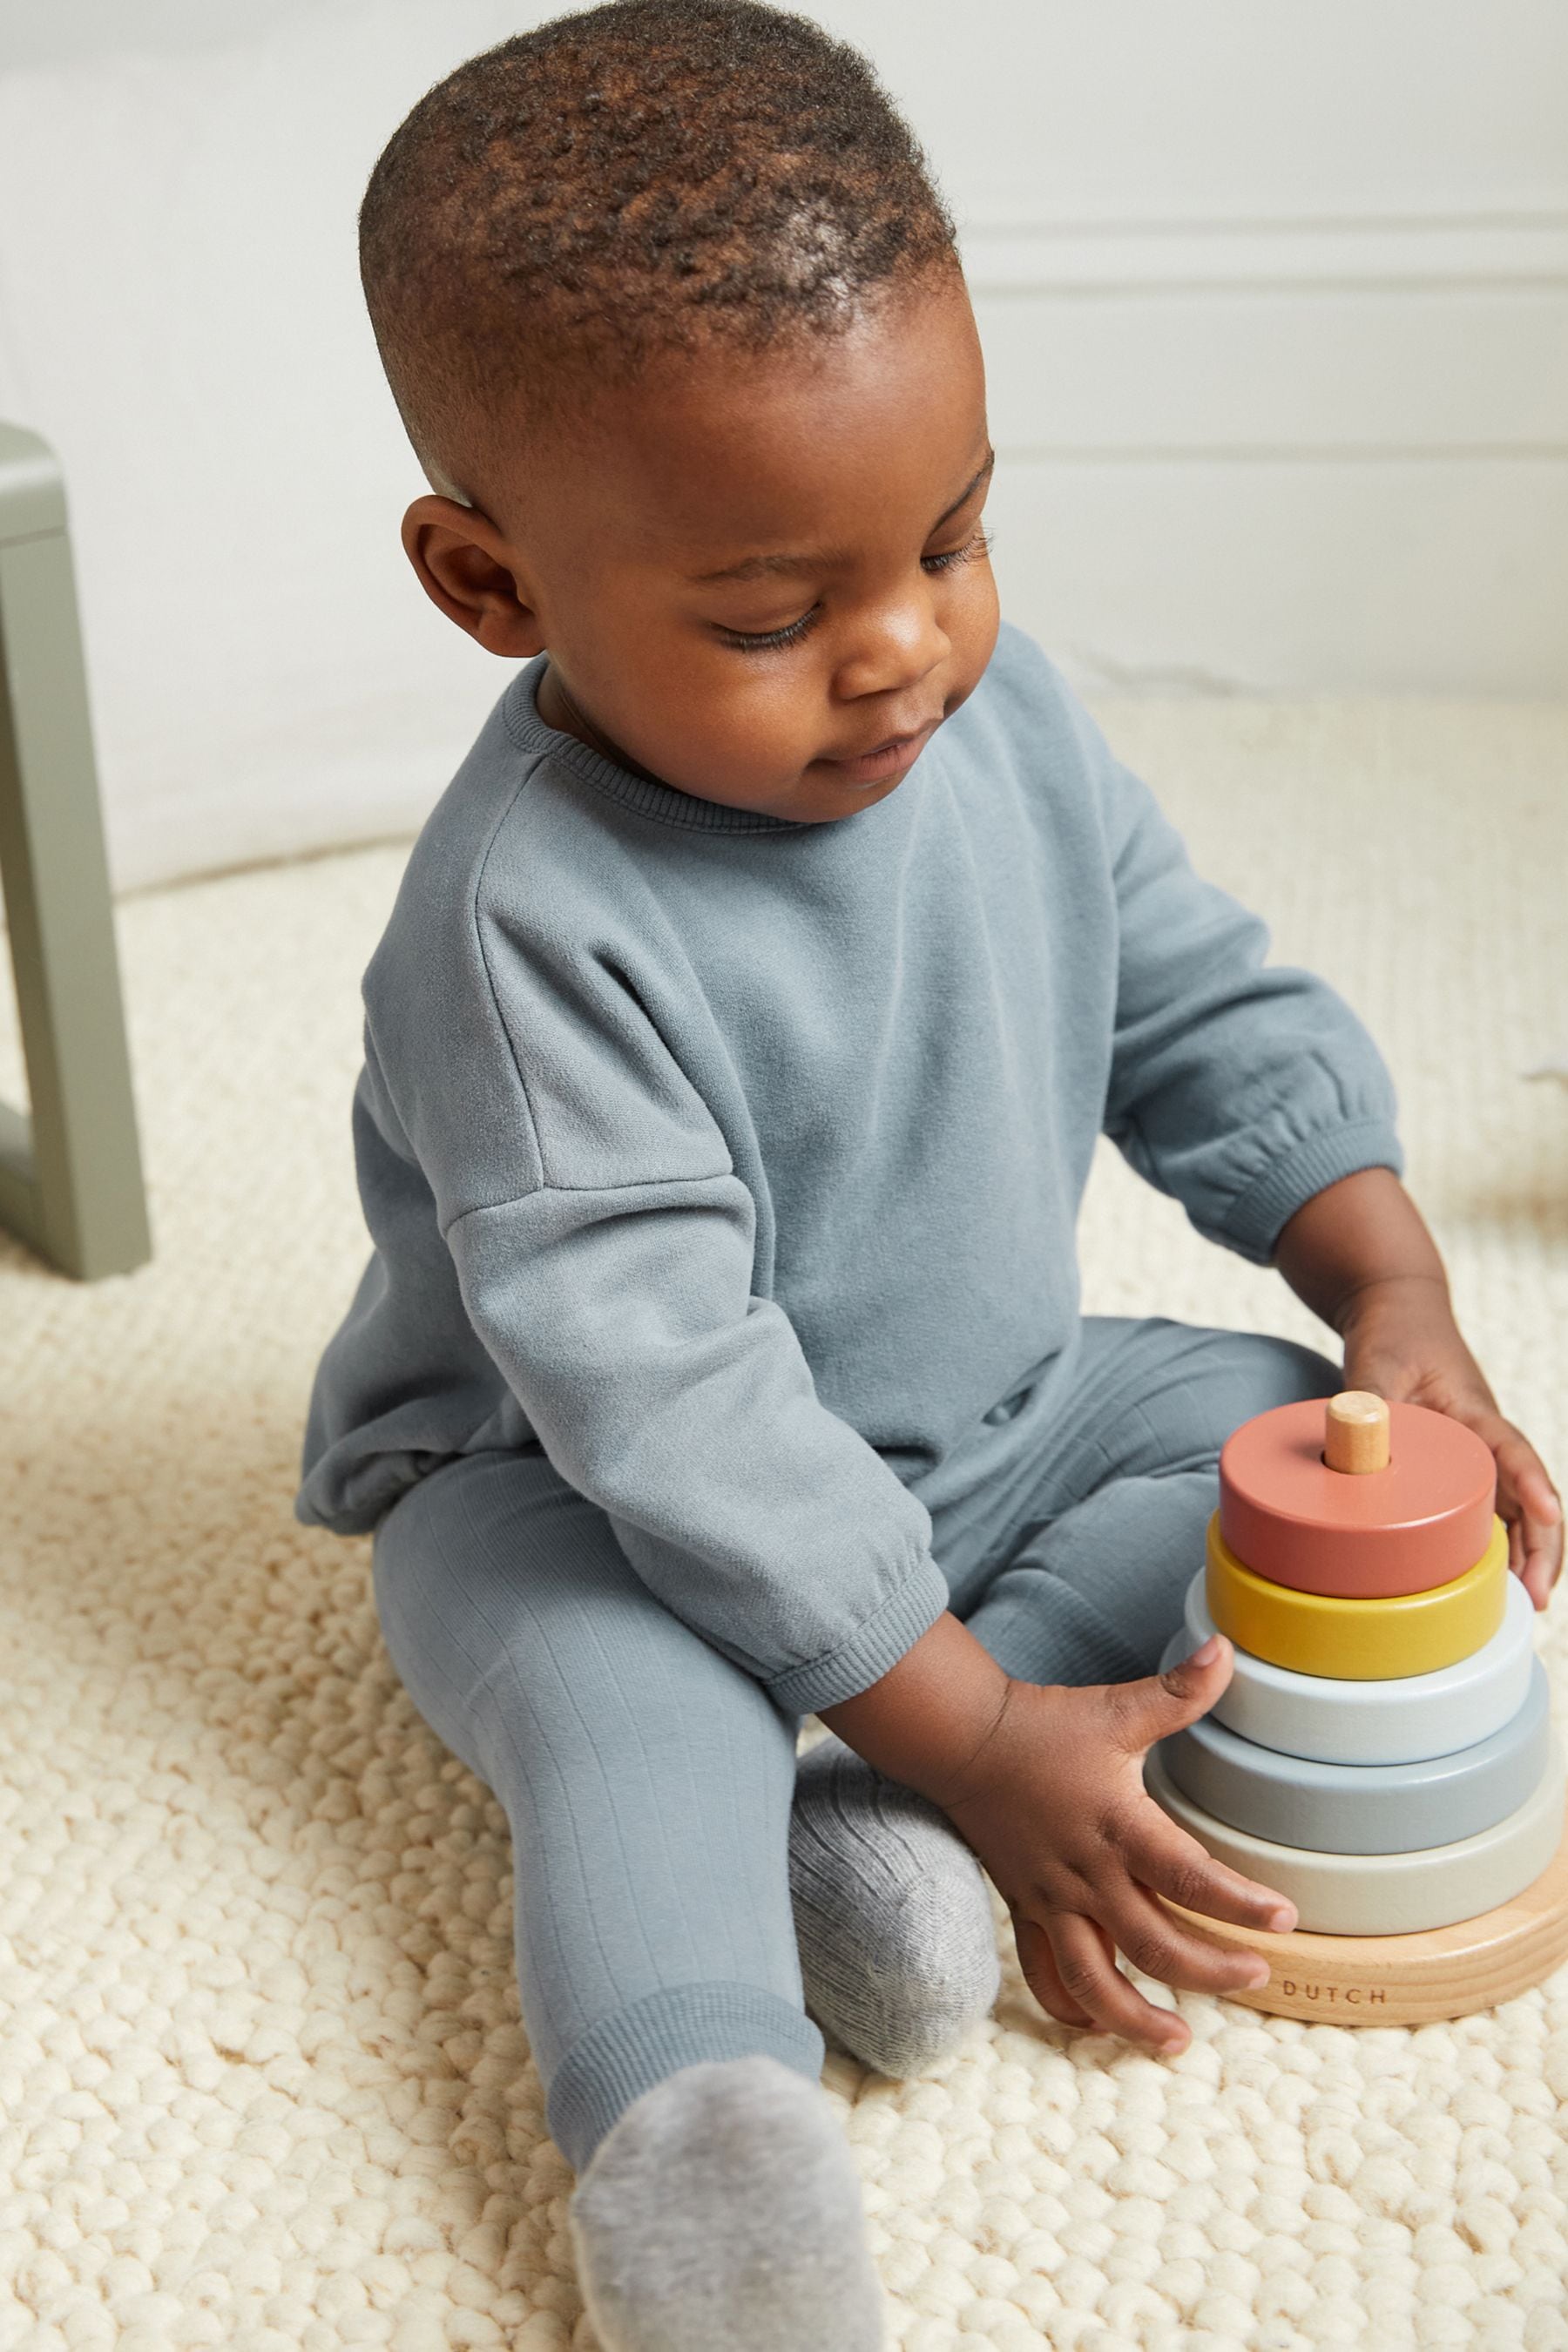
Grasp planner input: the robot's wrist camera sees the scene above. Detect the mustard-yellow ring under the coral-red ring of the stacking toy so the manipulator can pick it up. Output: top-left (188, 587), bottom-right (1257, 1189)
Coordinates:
top-left (1204, 1510), bottom-right (1510, 1682)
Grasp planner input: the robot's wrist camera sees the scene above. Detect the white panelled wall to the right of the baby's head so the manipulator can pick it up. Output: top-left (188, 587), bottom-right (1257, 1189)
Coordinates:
top-left (823, 0), bottom-right (1568, 694)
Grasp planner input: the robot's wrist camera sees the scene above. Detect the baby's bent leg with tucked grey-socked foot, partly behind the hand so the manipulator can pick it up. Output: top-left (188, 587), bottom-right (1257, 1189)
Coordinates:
top-left (790, 1317), bottom-right (1340, 2074)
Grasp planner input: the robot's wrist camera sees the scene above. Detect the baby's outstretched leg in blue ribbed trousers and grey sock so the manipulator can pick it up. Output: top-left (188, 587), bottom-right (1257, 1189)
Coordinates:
top-left (374, 1454), bottom-right (882, 2352)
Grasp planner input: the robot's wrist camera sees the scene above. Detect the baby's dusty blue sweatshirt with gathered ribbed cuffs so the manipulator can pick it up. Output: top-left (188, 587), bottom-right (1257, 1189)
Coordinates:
top-left (296, 628), bottom-right (1401, 1713)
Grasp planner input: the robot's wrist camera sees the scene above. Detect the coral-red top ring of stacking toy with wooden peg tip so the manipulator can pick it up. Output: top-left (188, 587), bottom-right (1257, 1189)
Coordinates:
top-left (1220, 1390), bottom-right (1497, 1599)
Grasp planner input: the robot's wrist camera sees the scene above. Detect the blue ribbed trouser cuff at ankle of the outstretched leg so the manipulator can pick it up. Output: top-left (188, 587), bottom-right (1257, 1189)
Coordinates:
top-left (545, 1985), bottom-right (823, 2173)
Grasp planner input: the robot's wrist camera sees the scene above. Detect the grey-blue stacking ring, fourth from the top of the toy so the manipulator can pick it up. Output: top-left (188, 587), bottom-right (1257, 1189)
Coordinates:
top-left (1159, 1637), bottom-right (1551, 1854)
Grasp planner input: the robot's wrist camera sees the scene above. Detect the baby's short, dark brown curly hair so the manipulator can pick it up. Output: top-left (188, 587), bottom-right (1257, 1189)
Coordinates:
top-left (360, 0), bottom-right (956, 497)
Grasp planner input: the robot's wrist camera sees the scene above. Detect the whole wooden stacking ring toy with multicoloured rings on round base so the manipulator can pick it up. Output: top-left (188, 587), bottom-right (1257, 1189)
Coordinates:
top-left (1145, 1390), bottom-right (1568, 2025)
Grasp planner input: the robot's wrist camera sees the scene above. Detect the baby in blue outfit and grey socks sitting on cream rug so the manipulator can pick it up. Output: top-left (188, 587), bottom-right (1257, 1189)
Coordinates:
top-left (296, 0), bottom-right (1561, 2352)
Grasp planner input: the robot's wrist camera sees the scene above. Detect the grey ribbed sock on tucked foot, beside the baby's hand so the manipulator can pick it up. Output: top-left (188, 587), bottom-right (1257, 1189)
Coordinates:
top-left (790, 1736), bottom-right (1002, 2079)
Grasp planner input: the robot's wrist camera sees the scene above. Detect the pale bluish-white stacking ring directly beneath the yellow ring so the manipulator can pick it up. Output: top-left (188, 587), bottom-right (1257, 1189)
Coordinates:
top-left (1164, 1569), bottom-right (1535, 1764)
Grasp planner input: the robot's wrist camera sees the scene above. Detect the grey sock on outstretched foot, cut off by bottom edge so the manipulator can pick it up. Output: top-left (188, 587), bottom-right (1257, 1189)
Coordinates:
top-left (571, 2058), bottom-right (882, 2352)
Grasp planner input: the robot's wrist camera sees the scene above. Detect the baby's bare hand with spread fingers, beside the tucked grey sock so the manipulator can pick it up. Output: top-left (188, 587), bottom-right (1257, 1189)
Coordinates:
top-left (821, 1616), bottom-right (1295, 2051)
